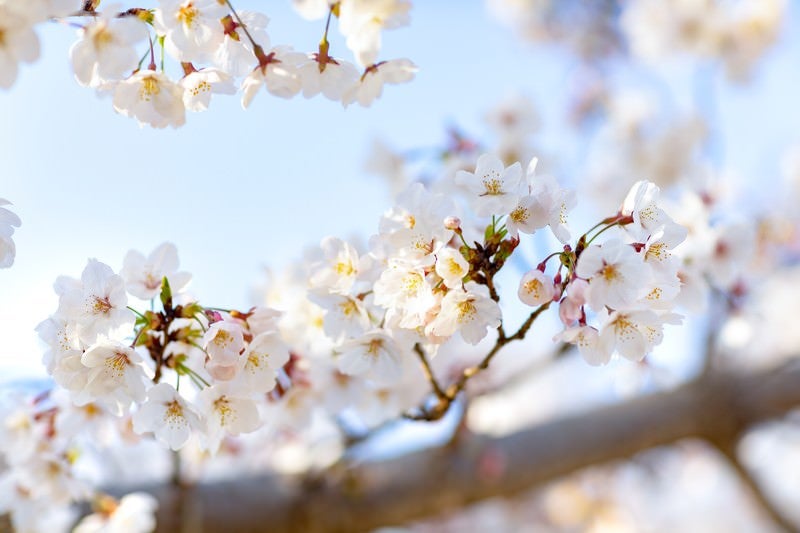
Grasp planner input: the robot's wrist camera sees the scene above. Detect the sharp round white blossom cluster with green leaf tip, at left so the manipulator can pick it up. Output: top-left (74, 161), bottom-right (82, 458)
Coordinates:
top-left (37, 243), bottom-right (289, 451)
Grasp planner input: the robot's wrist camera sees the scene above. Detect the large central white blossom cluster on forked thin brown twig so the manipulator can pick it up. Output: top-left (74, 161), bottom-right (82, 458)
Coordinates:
top-left (268, 150), bottom-right (686, 425)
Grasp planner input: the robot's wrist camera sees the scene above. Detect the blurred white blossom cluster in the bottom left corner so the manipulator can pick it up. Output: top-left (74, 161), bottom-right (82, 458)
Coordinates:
top-left (0, 389), bottom-right (157, 533)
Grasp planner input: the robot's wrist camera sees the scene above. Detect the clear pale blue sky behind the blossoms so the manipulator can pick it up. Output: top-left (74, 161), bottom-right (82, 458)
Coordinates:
top-left (0, 1), bottom-right (800, 379)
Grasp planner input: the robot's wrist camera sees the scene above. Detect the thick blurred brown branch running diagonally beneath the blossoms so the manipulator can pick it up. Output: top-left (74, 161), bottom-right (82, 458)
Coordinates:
top-left (123, 365), bottom-right (800, 533)
